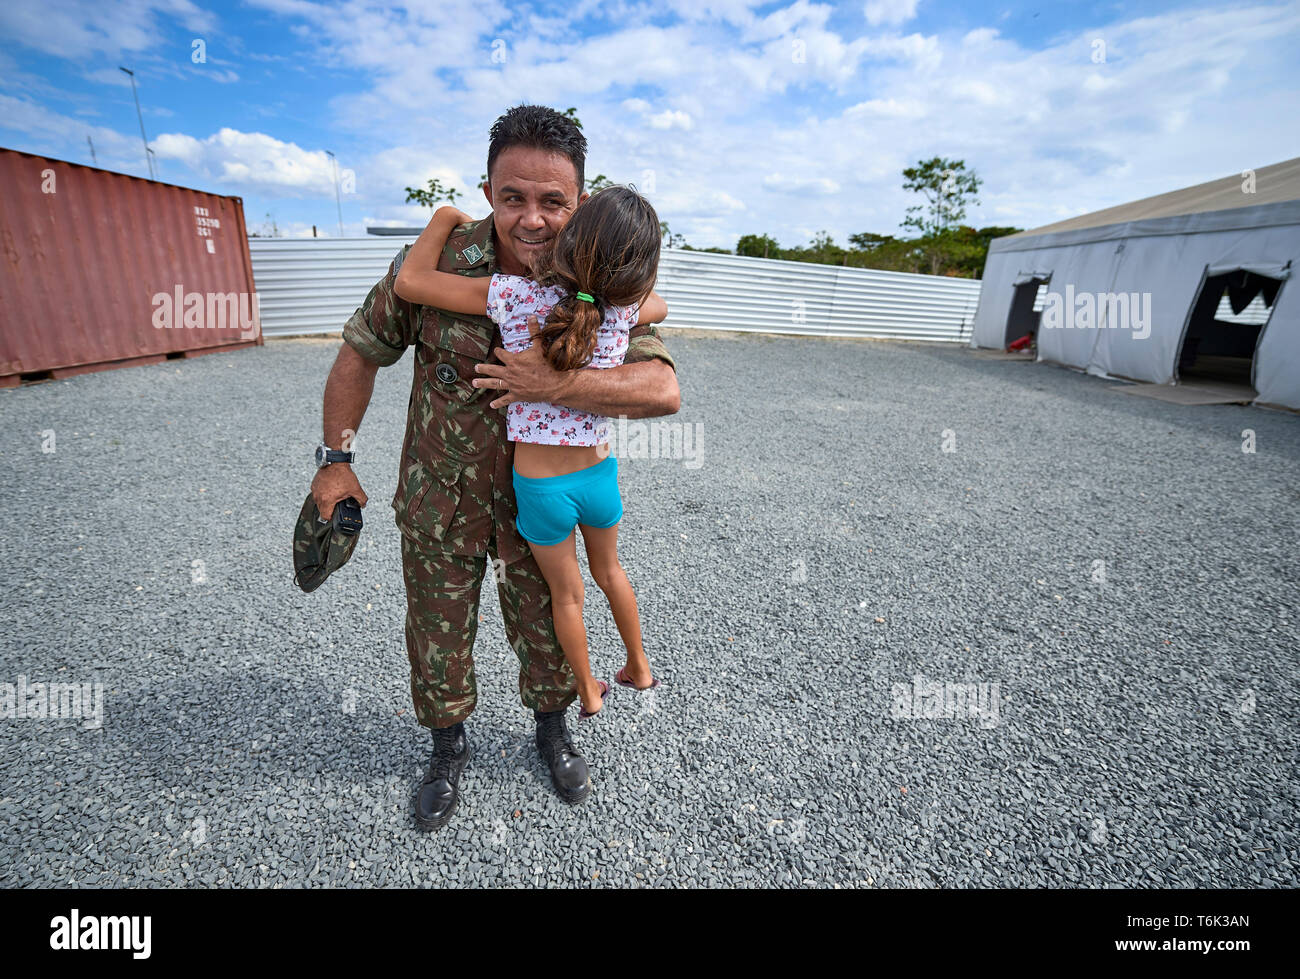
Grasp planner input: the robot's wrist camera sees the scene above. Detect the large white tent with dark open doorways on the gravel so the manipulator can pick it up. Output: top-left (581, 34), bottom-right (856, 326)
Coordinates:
top-left (971, 157), bottom-right (1300, 410)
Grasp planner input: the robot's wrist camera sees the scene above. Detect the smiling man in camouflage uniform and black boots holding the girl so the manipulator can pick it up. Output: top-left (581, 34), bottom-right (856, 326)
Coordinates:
top-left (313, 107), bottom-right (677, 828)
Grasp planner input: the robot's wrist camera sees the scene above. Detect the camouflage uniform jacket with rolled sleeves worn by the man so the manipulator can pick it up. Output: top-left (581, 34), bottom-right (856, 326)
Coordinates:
top-left (343, 217), bottom-right (676, 563)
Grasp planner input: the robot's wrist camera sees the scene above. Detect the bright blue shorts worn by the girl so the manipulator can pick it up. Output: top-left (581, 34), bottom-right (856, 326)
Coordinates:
top-left (515, 455), bottom-right (623, 546)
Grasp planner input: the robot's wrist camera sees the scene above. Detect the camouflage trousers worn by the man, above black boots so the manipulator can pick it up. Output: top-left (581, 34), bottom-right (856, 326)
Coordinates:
top-left (402, 533), bottom-right (577, 728)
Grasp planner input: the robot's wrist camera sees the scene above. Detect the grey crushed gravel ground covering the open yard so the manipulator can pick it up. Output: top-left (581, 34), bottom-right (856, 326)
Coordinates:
top-left (0, 334), bottom-right (1300, 888)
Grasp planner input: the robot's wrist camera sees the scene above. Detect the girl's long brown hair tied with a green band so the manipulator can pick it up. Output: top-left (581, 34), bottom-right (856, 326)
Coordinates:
top-left (534, 186), bottom-right (662, 371)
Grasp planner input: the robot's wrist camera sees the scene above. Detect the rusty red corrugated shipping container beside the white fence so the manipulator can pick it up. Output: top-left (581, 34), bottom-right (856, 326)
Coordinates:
top-left (0, 147), bottom-right (261, 387)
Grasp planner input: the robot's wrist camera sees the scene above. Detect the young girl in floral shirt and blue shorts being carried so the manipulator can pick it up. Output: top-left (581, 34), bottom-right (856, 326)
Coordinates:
top-left (397, 186), bottom-right (667, 718)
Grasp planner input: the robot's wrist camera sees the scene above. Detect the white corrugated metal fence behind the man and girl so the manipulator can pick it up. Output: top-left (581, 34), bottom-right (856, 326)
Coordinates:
top-left (248, 235), bottom-right (980, 342)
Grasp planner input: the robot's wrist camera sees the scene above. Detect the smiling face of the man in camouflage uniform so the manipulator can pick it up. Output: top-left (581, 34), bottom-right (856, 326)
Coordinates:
top-left (484, 146), bottom-right (588, 276)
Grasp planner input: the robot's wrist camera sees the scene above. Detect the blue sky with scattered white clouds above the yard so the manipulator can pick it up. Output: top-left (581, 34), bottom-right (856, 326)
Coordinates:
top-left (0, 0), bottom-right (1300, 247)
